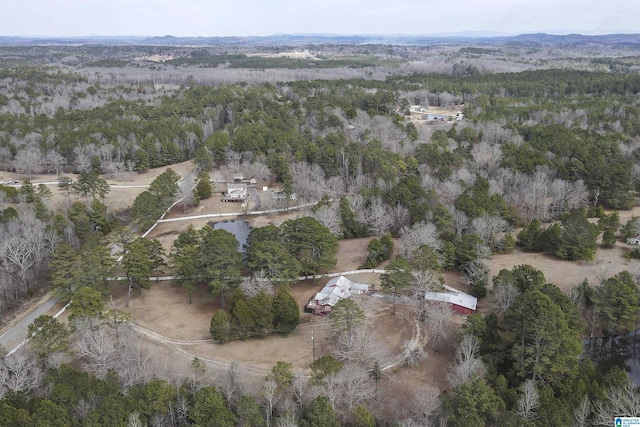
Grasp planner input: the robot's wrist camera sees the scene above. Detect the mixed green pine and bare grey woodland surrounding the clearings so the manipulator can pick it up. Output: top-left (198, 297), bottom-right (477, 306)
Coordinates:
top-left (0, 38), bottom-right (640, 426)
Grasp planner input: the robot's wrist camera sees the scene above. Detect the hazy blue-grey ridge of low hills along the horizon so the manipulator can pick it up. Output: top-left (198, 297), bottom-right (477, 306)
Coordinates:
top-left (0, 31), bottom-right (640, 47)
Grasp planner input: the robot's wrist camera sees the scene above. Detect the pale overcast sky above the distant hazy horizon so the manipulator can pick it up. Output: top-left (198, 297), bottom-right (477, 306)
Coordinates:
top-left (0, 0), bottom-right (640, 36)
